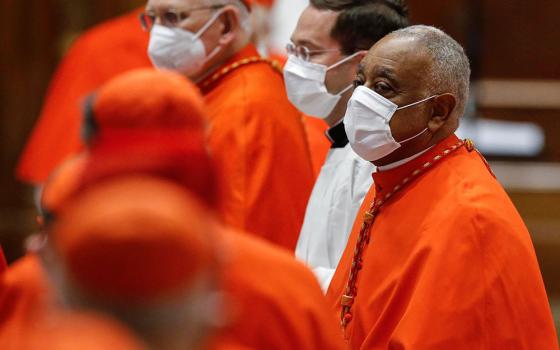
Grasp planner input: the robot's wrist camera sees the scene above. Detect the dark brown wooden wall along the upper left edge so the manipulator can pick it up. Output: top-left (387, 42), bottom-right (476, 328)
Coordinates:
top-left (0, 0), bottom-right (143, 260)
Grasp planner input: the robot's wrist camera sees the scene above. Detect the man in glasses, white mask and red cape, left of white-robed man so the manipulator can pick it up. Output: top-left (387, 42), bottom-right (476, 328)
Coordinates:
top-left (140, 0), bottom-right (313, 250)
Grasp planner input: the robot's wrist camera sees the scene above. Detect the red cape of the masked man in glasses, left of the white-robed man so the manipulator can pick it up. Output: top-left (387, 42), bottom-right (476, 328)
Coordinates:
top-left (199, 45), bottom-right (313, 250)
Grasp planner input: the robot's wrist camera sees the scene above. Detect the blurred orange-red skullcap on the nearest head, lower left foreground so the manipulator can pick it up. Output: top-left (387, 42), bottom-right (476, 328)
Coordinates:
top-left (51, 176), bottom-right (215, 304)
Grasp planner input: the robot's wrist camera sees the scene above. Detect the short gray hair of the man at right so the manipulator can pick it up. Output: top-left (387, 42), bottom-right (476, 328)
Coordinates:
top-left (389, 25), bottom-right (471, 117)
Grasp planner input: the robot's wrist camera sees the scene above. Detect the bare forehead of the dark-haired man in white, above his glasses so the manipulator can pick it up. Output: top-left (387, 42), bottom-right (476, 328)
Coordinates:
top-left (291, 5), bottom-right (339, 48)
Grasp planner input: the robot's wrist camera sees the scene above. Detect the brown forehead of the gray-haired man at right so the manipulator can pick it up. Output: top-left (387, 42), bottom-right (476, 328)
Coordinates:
top-left (362, 36), bottom-right (431, 81)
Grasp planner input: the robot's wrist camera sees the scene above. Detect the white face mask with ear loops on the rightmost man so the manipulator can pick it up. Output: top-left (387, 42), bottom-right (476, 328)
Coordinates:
top-left (344, 86), bottom-right (436, 161)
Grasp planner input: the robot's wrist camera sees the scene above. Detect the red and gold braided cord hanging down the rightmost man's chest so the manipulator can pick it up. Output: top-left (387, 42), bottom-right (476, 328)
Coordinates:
top-left (340, 139), bottom-right (474, 329)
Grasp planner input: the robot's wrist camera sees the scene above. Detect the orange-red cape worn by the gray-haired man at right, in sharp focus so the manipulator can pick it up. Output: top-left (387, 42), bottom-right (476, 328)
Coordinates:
top-left (327, 135), bottom-right (558, 350)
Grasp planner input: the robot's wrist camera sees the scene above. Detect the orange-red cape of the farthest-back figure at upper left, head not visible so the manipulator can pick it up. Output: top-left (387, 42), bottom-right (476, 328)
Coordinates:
top-left (17, 9), bottom-right (151, 184)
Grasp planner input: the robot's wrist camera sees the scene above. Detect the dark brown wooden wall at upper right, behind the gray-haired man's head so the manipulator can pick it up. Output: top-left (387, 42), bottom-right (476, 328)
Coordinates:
top-left (408, 0), bottom-right (560, 80)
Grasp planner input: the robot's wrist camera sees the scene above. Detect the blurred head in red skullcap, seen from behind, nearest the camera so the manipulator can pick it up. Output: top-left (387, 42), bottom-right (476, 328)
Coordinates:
top-left (42, 175), bottom-right (225, 349)
